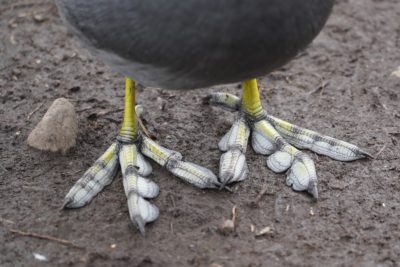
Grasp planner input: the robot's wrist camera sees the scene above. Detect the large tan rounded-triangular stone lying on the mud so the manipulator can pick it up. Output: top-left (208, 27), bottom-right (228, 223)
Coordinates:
top-left (27, 98), bottom-right (78, 154)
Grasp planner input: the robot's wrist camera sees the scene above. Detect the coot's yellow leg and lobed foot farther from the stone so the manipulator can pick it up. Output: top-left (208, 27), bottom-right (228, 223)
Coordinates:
top-left (208, 79), bottom-right (372, 199)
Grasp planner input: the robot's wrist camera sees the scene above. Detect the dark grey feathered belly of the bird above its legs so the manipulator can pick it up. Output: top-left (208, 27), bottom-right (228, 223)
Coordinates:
top-left (57, 0), bottom-right (333, 89)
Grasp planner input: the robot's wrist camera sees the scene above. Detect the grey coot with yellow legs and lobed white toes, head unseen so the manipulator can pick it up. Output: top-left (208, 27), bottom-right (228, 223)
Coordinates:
top-left (56, 0), bottom-right (369, 233)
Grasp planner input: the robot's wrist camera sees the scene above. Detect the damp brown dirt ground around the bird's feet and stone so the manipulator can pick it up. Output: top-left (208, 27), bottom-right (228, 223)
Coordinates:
top-left (0, 0), bottom-right (400, 266)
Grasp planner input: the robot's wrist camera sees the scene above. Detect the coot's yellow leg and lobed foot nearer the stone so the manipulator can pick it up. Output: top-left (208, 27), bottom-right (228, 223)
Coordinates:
top-left (63, 78), bottom-right (221, 234)
